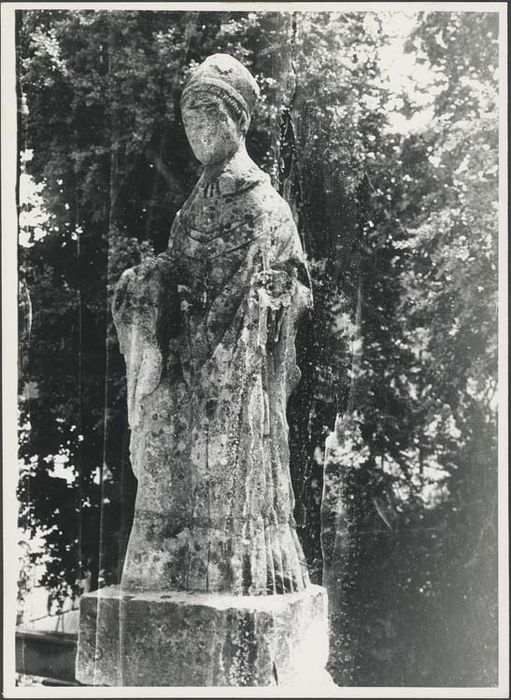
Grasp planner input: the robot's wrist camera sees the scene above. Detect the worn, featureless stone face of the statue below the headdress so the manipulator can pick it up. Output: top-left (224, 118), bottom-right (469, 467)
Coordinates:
top-left (181, 92), bottom-right (244, 165)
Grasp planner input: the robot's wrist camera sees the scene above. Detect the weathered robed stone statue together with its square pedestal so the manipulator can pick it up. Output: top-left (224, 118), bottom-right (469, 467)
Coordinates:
top-left (76, 54), bottom-right (330, 692)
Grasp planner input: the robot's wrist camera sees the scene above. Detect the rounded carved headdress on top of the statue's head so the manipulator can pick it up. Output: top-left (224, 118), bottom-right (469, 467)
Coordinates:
top-left (181, 53), bottom-right (259, 121)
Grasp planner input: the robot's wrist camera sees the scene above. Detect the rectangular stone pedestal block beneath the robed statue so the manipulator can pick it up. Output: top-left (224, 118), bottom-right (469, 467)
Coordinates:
top-left (76, 586), bottom-right (328, 688)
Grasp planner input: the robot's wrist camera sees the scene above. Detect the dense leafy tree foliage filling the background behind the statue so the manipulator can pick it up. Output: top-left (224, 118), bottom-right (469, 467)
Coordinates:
top-left (16, 10), bottom-right (498, 686)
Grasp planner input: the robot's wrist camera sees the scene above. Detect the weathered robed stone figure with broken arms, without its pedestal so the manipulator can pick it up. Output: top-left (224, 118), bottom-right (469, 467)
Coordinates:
top-left (113, 54), bottom-right (311, 595)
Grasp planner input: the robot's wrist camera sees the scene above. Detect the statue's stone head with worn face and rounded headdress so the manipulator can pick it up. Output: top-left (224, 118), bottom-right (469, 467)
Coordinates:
top-left (181, 53), bottom-right (259, 165)
